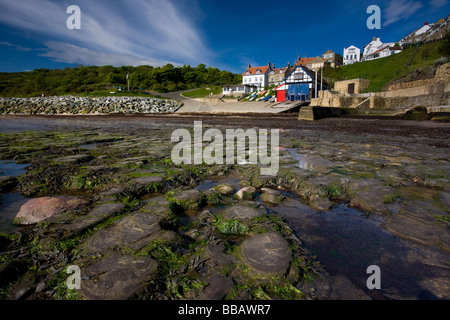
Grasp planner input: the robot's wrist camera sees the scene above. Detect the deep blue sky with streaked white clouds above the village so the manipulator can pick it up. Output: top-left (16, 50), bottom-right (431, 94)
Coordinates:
top-left (0, 0), bottom-right (450, 73)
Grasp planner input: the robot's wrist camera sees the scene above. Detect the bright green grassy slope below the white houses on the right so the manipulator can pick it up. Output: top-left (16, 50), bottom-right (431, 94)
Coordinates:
top-left (324, 42), bottom-right (441, 92)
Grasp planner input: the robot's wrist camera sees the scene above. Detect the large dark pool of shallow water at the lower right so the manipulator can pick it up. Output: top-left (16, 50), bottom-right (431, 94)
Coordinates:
top-left (271, 199), bottom-right (450, 299)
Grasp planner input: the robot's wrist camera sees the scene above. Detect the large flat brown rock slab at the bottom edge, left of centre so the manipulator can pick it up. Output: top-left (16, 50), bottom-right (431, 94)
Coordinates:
top-left (81, 252), bottom-right (158, 300)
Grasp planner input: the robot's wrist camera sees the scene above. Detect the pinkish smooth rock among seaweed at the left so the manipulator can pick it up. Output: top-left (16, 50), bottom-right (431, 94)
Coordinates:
top-left (14, 197), bottom-right (86, 225)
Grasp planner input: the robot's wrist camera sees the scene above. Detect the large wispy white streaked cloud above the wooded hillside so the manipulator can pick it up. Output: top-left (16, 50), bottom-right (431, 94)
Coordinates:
top-left (0, 0), bottom-right (211, 65)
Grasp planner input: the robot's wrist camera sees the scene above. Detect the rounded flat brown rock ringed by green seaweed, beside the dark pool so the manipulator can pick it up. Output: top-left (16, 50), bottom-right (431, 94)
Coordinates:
top-left (241, 232), bottom-right (291, 273)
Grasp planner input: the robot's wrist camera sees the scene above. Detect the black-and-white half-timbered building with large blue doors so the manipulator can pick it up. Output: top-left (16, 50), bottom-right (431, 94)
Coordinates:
top-left (285, 65), bottom-right (328, 101)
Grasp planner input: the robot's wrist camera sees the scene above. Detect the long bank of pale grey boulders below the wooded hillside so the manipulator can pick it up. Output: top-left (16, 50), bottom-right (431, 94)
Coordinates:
top-left (0, 96), bottom-right (183, 115)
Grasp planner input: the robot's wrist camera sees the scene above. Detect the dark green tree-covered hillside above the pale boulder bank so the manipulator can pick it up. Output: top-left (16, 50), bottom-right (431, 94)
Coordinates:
top-left (0, 64), bottom-right (242, 97)
